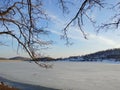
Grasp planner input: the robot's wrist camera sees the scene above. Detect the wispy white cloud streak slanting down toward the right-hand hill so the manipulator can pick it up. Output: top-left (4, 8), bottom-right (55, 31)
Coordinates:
top-left (46, 13), bottom-right (120, 48)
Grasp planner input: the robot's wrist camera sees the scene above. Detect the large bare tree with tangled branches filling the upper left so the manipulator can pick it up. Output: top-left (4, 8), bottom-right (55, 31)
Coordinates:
top-left (0, 0), bottom-right (51, 66)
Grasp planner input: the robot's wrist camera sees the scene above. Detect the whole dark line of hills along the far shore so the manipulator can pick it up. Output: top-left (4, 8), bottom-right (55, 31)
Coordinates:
top-left (0, 48), bottom-right (120, 62)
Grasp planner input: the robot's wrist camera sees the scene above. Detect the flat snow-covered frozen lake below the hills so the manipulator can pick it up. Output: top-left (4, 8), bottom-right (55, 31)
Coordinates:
top-left (0, 61), bottom-right (120, 90)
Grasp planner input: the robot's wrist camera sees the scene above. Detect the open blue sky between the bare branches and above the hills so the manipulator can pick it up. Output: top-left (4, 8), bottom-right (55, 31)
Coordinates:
top-left (0, 0), bottom-right (120, 58)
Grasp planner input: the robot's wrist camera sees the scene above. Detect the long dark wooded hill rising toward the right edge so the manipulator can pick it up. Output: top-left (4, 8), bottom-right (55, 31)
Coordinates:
top-left (61, 48), bottom-right (120, 61)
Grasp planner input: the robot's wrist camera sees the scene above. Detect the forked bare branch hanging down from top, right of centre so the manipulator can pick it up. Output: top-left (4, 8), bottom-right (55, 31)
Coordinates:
top-left (63, 0), bottom-right (103, 41)
